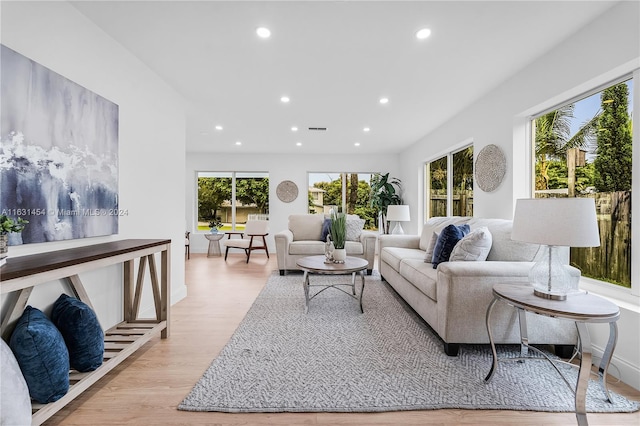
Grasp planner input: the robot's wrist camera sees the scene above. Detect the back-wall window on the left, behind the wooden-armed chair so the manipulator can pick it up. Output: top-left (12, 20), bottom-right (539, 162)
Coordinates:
top-left (197, 172), bottom-right (269, 231)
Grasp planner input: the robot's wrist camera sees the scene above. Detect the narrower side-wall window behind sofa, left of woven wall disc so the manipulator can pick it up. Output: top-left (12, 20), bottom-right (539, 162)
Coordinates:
top-left (425, 145), bottom-right (473, 218)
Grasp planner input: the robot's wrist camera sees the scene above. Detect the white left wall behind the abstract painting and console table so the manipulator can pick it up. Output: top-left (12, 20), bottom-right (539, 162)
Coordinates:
top-left (0, 2), bottom-right (186, 328)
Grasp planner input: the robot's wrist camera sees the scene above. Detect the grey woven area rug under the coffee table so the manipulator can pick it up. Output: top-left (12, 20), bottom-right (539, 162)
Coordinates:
top-left (178, 271), bottom-right (640, 412)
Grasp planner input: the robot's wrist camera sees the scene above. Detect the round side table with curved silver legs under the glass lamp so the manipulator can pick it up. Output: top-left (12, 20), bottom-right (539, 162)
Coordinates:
top-left (484, 284), bottom-right (620, 425)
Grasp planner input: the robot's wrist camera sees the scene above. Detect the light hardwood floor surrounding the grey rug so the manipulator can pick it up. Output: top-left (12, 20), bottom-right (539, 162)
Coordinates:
top-left (46, 253), bottom-right (640, 426)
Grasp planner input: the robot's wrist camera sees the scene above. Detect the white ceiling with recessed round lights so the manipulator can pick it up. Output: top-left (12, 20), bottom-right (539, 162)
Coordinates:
top-left (73, 1), bottom-right (615, 153)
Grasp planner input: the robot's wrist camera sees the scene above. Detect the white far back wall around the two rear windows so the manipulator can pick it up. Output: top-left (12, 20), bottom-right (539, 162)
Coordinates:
top-left (185, 153), bottom-right (400, 253)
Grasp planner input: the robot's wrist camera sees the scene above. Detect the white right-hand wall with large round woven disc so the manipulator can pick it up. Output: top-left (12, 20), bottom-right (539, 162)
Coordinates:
top-left (399, 2), bottom-right (640, 389)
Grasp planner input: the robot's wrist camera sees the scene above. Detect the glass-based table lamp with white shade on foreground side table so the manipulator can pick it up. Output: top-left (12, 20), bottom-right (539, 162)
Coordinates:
top-left (511, 198), bottom-right (600, 300)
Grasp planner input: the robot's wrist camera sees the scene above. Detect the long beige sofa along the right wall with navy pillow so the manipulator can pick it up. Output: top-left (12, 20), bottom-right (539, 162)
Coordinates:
top-left (379, 217), bottom-right (580, 356)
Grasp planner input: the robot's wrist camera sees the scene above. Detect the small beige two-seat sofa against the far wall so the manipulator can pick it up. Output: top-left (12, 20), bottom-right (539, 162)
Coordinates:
top-left (274, 214), bottom-right (378, 275)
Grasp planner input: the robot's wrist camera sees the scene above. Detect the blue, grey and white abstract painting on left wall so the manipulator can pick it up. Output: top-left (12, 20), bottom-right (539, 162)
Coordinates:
top-left (0, 45), bottom-right (119, 245)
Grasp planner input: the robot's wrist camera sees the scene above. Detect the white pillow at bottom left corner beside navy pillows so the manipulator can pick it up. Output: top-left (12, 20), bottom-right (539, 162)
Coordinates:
top-left (0, 339), bottom-right (31, 425)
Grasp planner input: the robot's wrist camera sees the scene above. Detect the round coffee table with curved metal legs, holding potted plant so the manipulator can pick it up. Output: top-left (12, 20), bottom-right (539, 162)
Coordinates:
top-left (296, 256), bottom-right (369, 313)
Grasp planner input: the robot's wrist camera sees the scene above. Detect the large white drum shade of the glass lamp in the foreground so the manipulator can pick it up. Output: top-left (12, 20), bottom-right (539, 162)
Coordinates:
top-left (511, 198), bottom-right (600, 247)
